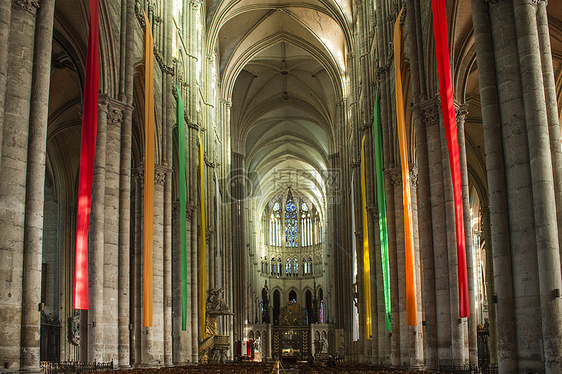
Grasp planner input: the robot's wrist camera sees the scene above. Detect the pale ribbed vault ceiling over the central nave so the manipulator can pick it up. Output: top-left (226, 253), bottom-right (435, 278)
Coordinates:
top-left (207, 0), bottom-right (352, 216)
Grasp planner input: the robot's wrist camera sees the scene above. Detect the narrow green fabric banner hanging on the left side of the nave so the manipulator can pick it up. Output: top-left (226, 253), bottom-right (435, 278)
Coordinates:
top-left (176, 87), bottom-right (187, 331)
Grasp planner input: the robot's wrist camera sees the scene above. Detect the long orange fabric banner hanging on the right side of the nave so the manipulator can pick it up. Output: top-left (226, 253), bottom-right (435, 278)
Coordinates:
top-left (394, 9), bottom-right (418, 325)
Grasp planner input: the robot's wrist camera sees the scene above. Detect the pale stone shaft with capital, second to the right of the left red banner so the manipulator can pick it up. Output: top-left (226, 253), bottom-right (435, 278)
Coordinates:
top-left (104, 99), bottom-right (124, 363)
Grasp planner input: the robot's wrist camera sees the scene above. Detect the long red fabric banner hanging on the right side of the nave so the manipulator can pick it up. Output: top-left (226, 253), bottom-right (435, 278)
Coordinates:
top-left (431, 0), bottom-right (470, 318)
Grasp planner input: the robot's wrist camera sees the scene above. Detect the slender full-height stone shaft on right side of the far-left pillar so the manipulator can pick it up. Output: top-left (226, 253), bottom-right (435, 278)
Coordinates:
top-left (19, 0), bottom-right (55, 372)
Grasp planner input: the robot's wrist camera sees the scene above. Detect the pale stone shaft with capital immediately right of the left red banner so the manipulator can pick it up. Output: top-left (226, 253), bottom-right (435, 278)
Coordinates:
top-left (88, 96), bottom-right (108, 362)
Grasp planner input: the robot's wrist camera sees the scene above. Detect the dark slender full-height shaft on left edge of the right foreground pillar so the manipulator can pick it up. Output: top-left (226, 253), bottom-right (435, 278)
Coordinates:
top-left (472, 0), bottom-right (517, 373)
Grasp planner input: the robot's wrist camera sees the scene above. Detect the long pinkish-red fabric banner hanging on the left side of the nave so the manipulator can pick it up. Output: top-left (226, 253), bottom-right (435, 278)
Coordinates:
top-left (74, 0), bottom-right (100, 310)
